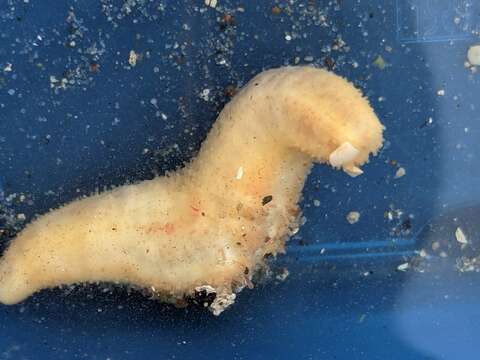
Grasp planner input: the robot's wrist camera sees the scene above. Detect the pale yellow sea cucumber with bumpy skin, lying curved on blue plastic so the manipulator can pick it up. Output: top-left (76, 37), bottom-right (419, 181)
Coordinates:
top-left (0, 66), bottom-right (383, 314)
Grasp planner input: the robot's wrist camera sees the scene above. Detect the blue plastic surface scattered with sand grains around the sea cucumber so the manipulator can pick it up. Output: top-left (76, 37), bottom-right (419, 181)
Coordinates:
top-left (0, 0), bottom-right (480, 360)
